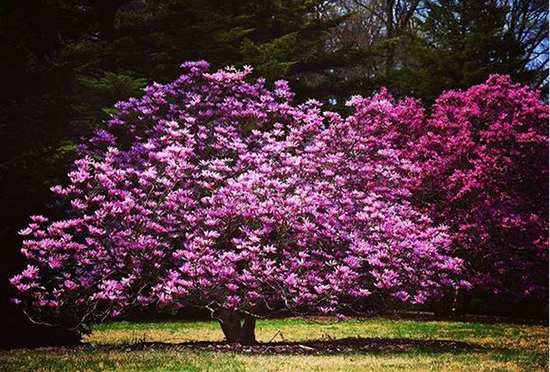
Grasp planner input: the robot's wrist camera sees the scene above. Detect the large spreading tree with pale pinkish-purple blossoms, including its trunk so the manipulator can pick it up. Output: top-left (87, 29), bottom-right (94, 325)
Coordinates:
top-left (11, 62), bottom-right (468, 342)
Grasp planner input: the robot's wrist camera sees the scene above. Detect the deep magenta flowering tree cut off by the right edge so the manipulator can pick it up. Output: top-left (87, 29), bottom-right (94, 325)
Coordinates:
top-left (410, 75), bottom-right (548, 300)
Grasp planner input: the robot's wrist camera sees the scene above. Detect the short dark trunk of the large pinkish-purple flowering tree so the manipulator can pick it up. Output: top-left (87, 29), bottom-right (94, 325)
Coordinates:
top-left (220, 309), bottom-right (256, 345)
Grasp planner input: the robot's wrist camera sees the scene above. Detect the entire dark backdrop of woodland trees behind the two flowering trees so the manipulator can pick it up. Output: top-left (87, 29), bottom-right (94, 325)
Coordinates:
top-left (0, 0), bottom-right (548, 348)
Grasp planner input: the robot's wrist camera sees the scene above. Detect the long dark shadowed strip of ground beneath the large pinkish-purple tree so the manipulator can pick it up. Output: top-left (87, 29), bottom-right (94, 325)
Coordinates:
top-left (91, 337), bottom-right (483, 355)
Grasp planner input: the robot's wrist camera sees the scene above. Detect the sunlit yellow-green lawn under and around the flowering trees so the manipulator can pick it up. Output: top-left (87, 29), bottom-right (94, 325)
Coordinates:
top-left (0, 318), bottom-right (548, 371)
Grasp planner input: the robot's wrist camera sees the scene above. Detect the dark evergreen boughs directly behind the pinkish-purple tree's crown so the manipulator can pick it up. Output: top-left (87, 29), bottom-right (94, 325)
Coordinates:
top-left (66, 0), bottom-right (358, 115)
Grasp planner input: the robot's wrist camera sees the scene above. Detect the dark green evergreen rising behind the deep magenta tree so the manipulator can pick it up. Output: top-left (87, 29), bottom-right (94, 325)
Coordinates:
top-left (388, 0), bottom-right (547, 103)
